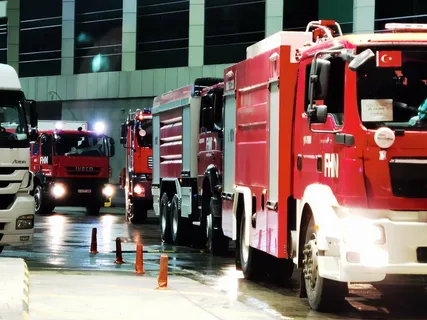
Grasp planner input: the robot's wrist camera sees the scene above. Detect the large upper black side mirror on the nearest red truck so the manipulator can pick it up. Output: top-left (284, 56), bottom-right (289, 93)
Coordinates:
top-left (308, 58), bottom-right (331, 101)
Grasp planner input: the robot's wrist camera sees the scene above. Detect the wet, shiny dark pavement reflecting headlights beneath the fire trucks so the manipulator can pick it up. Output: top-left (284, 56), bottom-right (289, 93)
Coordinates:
top-left (1, 208), bottom-right (427, 319)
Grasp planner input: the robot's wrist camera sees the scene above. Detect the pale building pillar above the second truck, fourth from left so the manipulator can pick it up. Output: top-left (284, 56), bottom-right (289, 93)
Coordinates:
top-left (188, 0), bottom-right (205, 67)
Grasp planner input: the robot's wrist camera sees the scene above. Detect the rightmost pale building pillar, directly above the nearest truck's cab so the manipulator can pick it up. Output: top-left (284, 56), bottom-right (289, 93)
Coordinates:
top-left (353, 0), bottom-right (375, 33)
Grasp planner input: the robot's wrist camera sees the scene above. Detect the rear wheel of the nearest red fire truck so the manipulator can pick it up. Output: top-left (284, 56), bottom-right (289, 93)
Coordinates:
top-left (239, 212), bottom-right (260, 280)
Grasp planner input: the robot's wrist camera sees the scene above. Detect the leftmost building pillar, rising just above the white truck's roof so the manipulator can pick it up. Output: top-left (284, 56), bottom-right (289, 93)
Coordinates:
top-left (6, 0), bottom-right (21, 74)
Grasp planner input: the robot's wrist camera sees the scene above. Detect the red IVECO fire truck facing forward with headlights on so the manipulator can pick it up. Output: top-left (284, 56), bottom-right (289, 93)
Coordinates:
top-left (31, 122), bottom-right (115, 215)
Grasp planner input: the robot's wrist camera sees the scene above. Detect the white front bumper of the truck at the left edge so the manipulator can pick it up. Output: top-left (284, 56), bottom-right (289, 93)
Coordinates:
top-left (0, 193), bottom-right (35, 246)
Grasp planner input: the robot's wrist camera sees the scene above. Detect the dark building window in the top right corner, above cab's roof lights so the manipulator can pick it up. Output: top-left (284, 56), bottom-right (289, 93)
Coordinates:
top-left (375, 0), bottom-right (427, 31)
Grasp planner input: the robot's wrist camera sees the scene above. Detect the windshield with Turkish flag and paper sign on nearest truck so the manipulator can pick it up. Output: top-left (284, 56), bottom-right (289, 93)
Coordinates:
top-left (357, 46), bottom-right (427, 130)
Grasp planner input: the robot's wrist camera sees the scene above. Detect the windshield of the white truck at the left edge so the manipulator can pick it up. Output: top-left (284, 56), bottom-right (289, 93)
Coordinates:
top-left (0, 90), bottom-right (30, 148)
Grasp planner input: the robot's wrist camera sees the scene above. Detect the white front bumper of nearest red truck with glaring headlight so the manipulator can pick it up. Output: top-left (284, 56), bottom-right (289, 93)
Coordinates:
top-left (318, 219), bottom-right (427, 282)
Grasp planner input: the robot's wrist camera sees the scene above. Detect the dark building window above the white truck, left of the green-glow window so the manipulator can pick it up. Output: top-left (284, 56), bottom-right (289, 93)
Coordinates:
top-left (19, 0), bottom-right (62, 77)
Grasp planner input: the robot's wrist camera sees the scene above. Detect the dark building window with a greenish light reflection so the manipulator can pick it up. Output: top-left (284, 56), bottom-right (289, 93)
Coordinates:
top-left (74, 0), bottom-right (123, 74)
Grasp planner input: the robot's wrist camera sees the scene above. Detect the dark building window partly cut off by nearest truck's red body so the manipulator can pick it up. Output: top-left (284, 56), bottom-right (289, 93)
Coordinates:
top-left (204, 0), bottom-right (265, 65)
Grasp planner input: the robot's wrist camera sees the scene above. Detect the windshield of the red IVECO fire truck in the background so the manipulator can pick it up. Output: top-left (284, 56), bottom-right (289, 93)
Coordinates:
top-left (54, 133), bottom-right (107, 157)
